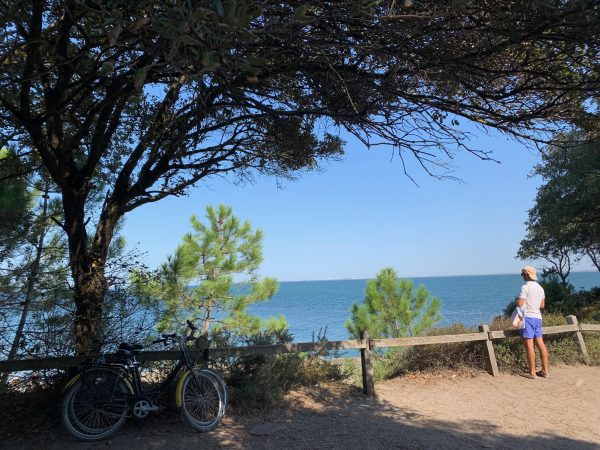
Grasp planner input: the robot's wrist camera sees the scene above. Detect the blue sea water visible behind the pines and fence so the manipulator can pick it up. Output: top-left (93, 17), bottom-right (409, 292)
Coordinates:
top-left (250, 272), bottom-right (600, 342)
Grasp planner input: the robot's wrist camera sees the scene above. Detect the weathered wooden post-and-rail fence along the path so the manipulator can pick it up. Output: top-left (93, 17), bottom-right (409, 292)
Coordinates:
top-left (0, 316), bottom-right (600, 396)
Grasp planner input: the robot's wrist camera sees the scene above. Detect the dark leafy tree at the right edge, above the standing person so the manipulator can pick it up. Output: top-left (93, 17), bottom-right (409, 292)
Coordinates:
top-left (518, 132), bottom-right (600, 283)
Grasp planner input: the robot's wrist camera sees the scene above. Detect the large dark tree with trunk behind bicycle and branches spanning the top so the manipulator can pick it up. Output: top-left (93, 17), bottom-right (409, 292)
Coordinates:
top-left (0, 0), bottom-right (600, 352)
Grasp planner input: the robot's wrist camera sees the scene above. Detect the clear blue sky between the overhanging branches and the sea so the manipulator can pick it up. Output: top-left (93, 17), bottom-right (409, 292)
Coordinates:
top-left (123, 126), bottom-right (588, 281)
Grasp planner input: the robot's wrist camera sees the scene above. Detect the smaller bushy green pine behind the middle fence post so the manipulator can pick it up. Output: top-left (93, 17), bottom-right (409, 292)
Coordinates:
top-left (346, 267), bottom-right (441, 338)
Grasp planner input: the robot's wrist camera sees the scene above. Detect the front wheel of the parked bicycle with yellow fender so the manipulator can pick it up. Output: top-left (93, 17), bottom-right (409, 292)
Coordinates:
top-left (181, 369), bottom-right (225, 433)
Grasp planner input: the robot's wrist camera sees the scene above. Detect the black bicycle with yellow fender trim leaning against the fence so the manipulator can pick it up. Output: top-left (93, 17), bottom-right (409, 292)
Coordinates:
top-left (61, 321), bottom-right (228, 441)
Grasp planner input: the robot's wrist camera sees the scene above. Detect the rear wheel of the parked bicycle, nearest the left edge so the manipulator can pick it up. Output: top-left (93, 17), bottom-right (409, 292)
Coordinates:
top-left (61, 368), bottom-right (133, 441)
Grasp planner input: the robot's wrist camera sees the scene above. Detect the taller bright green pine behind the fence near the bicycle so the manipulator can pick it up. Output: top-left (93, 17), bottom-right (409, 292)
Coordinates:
top-left (135, 205), bottom-right (287, 336)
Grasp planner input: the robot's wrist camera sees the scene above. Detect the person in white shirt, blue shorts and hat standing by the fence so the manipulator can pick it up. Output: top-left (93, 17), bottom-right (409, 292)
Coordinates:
top-left (517, 266), bottom-right (549, 380)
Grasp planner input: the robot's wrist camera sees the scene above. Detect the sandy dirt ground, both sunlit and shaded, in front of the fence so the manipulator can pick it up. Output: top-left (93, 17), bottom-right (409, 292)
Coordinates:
top-left (0, 366), bottom-right (600, 450)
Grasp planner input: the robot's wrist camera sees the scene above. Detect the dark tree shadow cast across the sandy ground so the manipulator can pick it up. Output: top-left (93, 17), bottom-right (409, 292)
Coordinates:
top-left (0, 382), bottom-right (600, 450)
